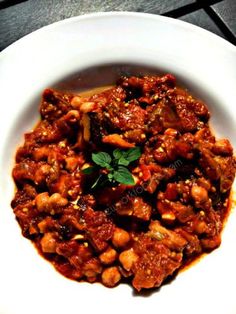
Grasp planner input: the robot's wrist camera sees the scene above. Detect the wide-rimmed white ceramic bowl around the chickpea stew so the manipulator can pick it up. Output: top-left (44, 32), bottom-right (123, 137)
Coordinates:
top-left (0, 13), bottom-right (236, 314)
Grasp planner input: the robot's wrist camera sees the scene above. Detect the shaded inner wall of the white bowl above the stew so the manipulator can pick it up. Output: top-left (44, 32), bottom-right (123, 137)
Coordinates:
top-left (1, 62), bottom-right (236, 215)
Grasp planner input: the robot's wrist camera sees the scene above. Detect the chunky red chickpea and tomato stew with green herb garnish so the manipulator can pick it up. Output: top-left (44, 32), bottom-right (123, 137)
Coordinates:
top-left (12, 74), bottom-right (236, 291)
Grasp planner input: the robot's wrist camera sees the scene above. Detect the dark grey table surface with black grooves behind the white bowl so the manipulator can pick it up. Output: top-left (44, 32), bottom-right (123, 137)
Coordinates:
top-left (0, 0), bottom-right (236, 51)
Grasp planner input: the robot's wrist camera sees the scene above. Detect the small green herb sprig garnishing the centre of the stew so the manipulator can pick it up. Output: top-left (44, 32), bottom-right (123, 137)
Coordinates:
top-left (82, 147), bottom-right (141, 188)
